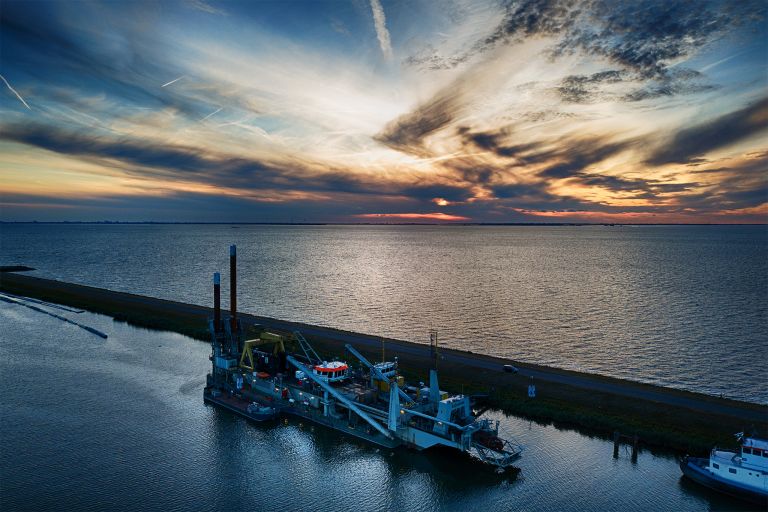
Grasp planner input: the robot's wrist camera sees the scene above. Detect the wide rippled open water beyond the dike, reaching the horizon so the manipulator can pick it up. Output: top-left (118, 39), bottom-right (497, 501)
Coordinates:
top-left (0, 225), bottom-right (768, 403)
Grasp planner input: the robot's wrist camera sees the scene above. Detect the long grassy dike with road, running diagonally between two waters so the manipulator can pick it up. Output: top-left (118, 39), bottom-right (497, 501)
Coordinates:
top-left (0, 273), bottom-right (768, 454)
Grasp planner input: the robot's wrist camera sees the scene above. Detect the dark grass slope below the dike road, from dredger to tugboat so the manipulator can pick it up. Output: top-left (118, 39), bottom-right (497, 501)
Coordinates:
top-left (311, 338), bottom-right (768, 454)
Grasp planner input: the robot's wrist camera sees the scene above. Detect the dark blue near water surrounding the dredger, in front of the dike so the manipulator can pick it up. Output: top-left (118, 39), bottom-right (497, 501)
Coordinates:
top-left (0, 303), bottom-right (743, 512)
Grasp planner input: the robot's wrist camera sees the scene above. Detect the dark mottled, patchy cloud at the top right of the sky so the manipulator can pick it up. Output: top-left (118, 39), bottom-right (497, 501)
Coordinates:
top-left (406, 0), bottom-right (766, 77)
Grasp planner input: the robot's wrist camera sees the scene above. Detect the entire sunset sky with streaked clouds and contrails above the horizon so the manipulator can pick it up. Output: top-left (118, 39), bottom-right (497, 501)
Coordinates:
top-left (0, 0), bottom-right (768, 223)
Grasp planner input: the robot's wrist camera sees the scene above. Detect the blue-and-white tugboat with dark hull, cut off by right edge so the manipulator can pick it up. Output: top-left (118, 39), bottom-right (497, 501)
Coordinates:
top-left (680, 434), bottom-right (768, 505)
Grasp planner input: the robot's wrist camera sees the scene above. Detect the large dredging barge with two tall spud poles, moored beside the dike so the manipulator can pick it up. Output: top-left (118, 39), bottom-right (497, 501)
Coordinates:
top-left (203, 245), bottom-right (522, 472)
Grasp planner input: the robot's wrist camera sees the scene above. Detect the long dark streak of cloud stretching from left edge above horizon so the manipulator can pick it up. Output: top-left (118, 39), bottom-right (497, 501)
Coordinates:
top-left (0, 125), bottom-right (468, 206)
